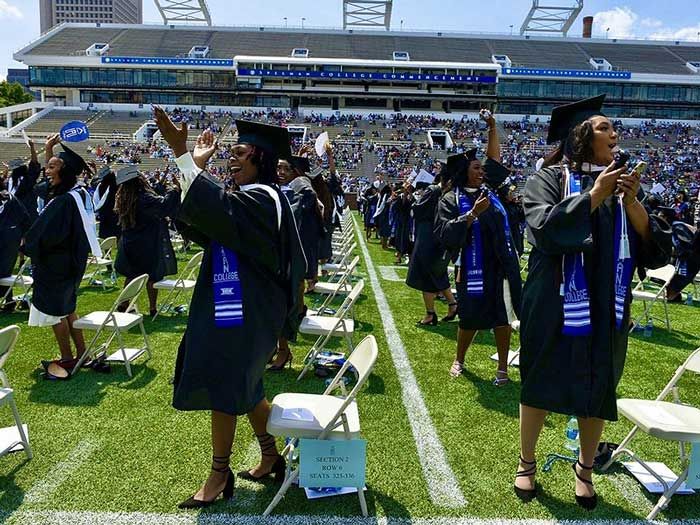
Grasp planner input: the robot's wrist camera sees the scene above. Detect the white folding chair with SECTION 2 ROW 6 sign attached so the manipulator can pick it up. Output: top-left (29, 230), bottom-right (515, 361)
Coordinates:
top-left (263, 335), bottom-right (379, 516)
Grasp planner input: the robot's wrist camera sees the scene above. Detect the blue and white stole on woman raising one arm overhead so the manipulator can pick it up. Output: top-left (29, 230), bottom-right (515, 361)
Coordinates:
top-left (455, 188), bottom-right (514, 296)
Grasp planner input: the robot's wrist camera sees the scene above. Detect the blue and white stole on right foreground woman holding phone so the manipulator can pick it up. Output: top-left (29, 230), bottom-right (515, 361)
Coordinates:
top-left (560, 165), bottom-right (633, 336)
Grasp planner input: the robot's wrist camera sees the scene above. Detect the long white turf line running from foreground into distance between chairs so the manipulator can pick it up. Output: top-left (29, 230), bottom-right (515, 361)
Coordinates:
top-left (353, 217), bottom-right (467, 508)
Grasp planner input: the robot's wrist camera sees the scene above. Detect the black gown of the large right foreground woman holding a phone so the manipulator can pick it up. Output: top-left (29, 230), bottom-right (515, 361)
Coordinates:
top-left (520, 167), bottom-right (671, 421)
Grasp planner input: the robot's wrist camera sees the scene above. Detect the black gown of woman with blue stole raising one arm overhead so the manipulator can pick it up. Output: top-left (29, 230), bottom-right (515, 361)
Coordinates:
top-left (435, 186), bottom-right (522, 330)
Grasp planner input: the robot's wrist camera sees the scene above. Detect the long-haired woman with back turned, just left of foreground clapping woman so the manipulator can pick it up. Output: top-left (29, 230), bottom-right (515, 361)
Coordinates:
top-left (114, 166), bottom-right (180, 317)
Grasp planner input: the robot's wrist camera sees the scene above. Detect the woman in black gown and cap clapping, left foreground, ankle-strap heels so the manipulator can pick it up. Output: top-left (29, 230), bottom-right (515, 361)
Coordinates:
top-left (154, 108), bottom-right (306, 508)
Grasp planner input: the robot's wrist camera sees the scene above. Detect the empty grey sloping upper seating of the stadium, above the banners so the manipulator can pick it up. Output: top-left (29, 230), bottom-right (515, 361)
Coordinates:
top-left (15, 24), bottom-right (700, 75)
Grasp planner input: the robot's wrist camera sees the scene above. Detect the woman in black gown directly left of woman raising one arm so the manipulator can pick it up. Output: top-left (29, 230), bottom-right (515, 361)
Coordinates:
top-left (404, 170), bottom-right (457, 326)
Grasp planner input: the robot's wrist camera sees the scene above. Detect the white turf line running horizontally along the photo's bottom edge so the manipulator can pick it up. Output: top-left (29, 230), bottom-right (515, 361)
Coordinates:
top-left (5, 509), bottom-right (700, 525)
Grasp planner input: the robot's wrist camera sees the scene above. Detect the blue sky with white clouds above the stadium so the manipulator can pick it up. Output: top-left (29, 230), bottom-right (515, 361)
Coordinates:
top-left (0, 0), bottom-right (700, 78)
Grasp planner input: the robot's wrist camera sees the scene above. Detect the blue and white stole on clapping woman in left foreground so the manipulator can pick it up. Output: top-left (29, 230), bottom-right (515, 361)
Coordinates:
top-left (211, 184), bottom-right (282, 328)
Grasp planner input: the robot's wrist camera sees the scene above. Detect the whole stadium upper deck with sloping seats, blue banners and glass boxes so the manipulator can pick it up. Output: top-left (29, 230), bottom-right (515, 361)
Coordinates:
top-left (9, 24), bottom-right (700, 119)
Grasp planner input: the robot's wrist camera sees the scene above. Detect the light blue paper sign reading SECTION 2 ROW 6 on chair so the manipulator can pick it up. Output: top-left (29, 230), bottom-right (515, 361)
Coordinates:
top-left (299, 439), bottom-right (367, 489)
